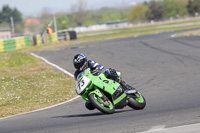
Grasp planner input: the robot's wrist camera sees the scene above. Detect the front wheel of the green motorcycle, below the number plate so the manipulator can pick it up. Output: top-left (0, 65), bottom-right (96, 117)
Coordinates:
top-left (89, 93), bottom-right (115, 114)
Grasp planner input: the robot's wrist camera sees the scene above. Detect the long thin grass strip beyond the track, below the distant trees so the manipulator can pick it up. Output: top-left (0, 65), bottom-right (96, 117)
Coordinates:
top-left (78, 18), bottom-right (200, 41)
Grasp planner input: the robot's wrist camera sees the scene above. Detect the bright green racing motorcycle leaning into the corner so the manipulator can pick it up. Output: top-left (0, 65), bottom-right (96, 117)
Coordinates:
top-left (76, 68), bottom-right (146, 114)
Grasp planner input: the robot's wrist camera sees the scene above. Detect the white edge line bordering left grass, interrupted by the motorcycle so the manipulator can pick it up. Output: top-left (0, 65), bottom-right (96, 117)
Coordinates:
top-left (0, 53), bottom-right (80, 120)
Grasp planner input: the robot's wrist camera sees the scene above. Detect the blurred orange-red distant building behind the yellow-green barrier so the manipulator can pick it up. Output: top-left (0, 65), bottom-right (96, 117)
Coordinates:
top-left (24, 18), bottom-right (40, 35)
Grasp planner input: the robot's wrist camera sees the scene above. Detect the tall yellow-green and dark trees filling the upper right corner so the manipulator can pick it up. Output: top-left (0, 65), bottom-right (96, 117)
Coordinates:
top-left (128, 0), bottom-right (200, 23)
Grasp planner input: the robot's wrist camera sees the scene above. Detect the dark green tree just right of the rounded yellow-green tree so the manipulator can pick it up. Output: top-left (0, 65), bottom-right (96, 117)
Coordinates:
top-left (145, 0), bottom-right (164, 21)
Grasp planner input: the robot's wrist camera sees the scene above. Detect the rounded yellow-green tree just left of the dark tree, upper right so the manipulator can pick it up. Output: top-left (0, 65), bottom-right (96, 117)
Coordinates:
top-left (128, 4), bottom-right (147, 22)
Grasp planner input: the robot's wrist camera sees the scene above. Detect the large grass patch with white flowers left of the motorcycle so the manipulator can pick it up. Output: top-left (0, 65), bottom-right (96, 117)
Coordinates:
top-left (0, 51), bottom-right (76, 117)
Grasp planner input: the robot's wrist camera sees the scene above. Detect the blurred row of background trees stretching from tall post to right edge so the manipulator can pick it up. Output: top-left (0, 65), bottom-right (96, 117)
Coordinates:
top-left (53, 0), bottom-right (200, 29)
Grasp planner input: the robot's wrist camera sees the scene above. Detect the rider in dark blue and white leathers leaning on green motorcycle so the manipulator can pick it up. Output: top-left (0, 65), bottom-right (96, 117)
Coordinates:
top-left (73, 54), bottom-right (132, 110)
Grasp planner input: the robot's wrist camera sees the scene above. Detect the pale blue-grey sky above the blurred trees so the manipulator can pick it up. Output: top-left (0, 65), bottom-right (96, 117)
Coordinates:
top-left (0, 0), bottom-right (145, 17)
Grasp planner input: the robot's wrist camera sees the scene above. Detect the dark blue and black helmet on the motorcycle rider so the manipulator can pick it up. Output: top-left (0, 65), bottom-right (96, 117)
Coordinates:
top-left (73, 54), bottom-right (87, 71)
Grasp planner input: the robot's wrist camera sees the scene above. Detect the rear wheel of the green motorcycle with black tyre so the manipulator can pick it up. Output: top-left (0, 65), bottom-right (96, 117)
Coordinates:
top-left (128, 94), bottom-right (146, 110)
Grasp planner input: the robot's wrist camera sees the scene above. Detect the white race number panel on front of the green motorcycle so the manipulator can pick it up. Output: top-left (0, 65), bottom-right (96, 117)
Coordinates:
top-left (76, 76), bottom-right (90, 94)
